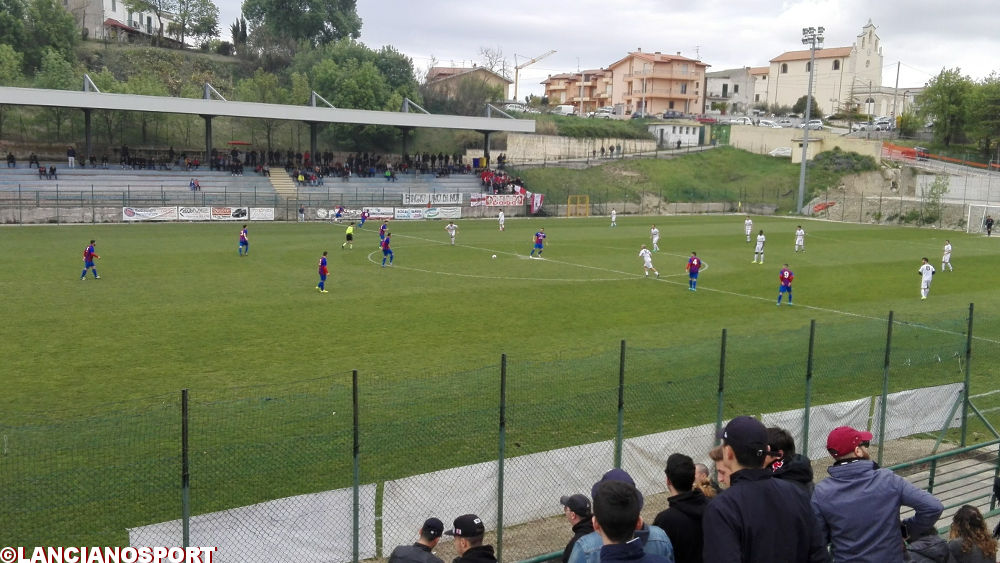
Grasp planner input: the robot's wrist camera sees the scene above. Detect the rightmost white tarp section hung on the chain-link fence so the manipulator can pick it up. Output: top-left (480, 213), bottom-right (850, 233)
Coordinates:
top-left (872, 383), bottom-right (962, 443)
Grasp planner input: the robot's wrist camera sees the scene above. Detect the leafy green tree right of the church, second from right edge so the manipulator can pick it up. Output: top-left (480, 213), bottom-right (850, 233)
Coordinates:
top-left (917, 68), bottom-right (972, 146)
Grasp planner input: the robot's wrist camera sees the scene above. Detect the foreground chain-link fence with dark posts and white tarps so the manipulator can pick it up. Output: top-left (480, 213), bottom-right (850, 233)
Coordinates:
top-left (0, 307), bottom-right (1000, 562)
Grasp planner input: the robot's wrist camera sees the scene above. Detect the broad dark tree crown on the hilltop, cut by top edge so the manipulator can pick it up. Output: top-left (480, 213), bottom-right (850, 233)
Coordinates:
top-left (243, 0), bottom-right (361, 51)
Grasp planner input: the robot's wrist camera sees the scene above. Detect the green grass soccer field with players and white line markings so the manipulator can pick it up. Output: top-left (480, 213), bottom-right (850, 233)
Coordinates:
top-left (0, 215), bottom-right (1000, 545)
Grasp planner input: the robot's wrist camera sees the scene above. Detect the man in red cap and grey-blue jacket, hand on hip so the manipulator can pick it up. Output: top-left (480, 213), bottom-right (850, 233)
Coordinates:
top-left (812, 426), bottom-right (944, 563)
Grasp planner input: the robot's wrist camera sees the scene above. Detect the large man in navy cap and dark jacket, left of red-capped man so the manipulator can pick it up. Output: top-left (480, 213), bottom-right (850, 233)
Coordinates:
top-left (702, 416), bottom-right (828, 563)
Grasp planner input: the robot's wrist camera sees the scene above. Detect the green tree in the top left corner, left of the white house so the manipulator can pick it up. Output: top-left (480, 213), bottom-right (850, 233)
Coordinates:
top-left (23, 0), bottom-right (79, 71)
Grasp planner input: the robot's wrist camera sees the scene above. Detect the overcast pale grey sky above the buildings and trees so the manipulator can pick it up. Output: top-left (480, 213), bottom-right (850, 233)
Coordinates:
top-left (217, 0), bottom-right (1000, 99)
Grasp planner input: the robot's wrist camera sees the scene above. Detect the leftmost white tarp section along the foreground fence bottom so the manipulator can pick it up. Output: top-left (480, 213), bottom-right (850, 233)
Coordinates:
top-left (128, 484), bottom-right (376, 563)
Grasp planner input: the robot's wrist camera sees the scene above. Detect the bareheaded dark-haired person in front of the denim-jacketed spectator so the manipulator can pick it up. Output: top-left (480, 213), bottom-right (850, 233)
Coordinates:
top-left (594, 481), bottom-right (674, 563)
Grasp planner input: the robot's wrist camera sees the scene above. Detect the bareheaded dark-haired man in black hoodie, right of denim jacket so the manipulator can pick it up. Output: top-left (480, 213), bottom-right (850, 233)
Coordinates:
top-left (653, 454), bottom-right (708, 563)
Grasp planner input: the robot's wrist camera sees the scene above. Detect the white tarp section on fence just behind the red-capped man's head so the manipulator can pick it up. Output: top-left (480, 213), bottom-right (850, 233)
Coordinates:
top-left (761, 397), bottom-right (872, 459)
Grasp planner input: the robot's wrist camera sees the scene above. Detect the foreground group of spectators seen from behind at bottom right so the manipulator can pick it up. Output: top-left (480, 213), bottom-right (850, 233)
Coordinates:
top-left (389, 424), bottom-right (1000, 563)
